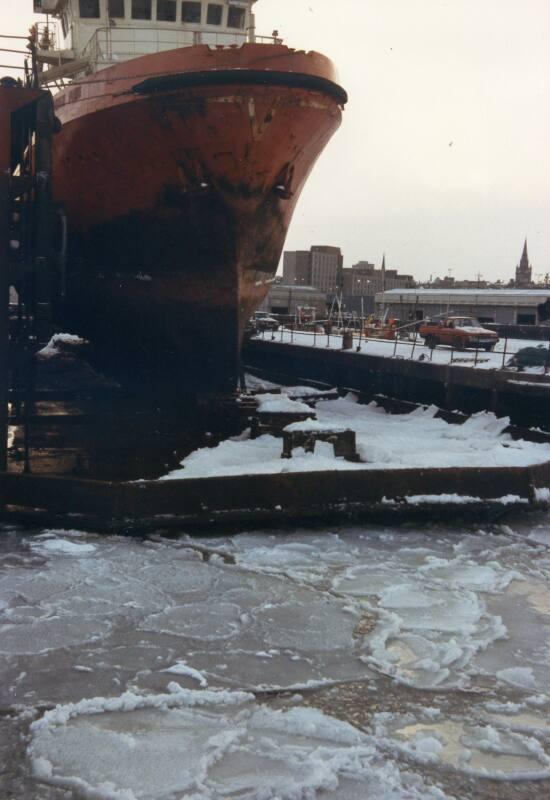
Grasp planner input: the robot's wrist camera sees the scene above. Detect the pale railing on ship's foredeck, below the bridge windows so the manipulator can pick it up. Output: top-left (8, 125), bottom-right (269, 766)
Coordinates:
top-left (82, 26), bottom-right (282, 68)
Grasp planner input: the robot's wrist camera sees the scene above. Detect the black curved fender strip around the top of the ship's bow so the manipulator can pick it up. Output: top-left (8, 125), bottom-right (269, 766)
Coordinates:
top-left (132, 69), bottom-right (348, 105)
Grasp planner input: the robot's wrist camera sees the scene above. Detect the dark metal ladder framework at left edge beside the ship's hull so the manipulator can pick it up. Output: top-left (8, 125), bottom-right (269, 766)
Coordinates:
top-left (0, 86), bottom-right (59, 472)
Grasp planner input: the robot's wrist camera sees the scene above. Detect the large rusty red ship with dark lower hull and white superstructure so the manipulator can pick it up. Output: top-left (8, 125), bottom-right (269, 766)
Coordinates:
top-left (33, 0), bottom-right (347, 394)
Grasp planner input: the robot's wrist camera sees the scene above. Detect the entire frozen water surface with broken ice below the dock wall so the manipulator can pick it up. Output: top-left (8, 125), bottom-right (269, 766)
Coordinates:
top-left (0, 514), bottom-right (550, 800)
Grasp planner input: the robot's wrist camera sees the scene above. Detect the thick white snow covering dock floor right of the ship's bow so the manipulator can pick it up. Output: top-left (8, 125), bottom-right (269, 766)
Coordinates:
top-left (161, 387), bottom-right (550, 480)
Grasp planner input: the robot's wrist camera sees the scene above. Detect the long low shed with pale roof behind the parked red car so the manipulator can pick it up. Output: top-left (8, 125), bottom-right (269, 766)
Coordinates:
top-left (376, 288), bottom-right (550, 325)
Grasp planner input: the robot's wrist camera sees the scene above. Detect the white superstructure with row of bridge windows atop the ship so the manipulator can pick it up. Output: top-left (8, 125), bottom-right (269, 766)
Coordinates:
top-left (34, 0), bottom-right (266, 83)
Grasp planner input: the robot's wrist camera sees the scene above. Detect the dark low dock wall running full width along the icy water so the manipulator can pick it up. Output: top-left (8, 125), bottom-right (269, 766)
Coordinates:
top-left (0, 462), bottom-right (550, 531)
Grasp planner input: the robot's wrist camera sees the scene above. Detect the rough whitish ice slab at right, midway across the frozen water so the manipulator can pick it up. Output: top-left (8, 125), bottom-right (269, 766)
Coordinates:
top-left (333, 553), bottom-right (540, 688)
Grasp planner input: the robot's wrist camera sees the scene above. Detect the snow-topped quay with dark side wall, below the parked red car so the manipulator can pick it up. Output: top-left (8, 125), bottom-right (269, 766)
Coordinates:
top-left (248, 326), bottom-right (550, 431)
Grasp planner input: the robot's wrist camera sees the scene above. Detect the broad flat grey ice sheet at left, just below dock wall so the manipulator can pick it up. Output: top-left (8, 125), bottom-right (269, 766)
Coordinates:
top-left (0, 533), bottom-right (374, 701)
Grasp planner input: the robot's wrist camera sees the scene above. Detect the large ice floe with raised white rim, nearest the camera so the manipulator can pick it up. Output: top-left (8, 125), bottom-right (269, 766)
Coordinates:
top-left (28, 692), bottom-right (450, 800)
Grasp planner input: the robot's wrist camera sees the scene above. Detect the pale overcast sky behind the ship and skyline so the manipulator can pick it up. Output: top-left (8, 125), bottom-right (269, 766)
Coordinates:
top-left (0, 0), bottom-right (550, 279)
